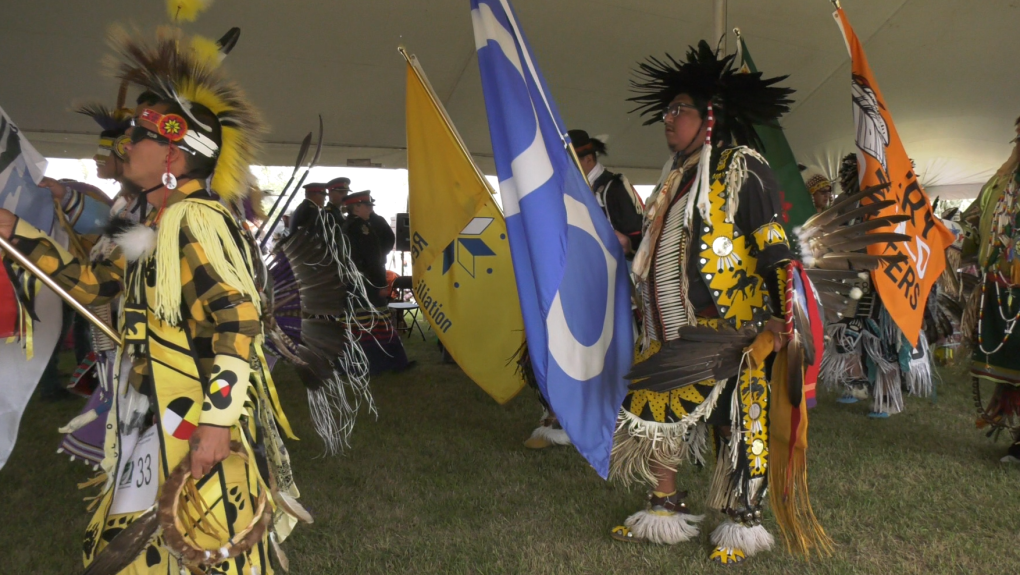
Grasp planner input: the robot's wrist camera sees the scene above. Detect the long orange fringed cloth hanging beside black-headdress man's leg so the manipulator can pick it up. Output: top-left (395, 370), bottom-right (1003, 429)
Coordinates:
top-left (768, 349), bottom-right (834, 559)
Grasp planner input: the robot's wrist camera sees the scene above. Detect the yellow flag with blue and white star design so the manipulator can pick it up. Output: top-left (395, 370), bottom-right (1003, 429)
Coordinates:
top-left (401, 50), bottom-right (524, 404)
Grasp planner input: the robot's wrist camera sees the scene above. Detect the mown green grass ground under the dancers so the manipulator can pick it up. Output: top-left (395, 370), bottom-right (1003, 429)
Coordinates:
top-left (0, 333), bottom-right (1020, 575)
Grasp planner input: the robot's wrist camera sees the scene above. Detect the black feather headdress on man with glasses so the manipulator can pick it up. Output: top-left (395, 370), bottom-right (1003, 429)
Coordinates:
top-left (628, 40), bottom-right (794, 150)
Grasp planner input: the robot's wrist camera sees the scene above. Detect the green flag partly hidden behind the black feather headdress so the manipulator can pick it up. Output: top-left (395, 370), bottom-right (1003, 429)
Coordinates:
top-left (736, 37), bottom-right (815, 230)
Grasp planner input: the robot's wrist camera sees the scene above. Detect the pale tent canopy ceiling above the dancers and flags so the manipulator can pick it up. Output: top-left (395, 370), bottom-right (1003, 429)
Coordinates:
top-left (0, 0), bottom-right (1020, 198)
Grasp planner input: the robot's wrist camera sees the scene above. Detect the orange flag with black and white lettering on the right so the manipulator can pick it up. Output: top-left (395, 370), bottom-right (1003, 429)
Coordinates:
top-left (832, 8), bottom-right (954, 346)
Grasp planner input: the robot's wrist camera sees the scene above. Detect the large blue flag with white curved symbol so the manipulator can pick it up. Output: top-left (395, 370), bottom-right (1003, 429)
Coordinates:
top-left (471, 0), bottom-right (633, 477)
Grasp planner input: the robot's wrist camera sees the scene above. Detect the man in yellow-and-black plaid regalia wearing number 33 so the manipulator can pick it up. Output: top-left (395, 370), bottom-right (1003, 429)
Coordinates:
top-left (0, 21), bottom-right (310, 575)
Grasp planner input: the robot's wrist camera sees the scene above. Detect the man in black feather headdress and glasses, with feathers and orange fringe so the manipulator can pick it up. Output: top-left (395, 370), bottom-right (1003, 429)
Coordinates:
top-left (610, 42), bottom-right (907, 564)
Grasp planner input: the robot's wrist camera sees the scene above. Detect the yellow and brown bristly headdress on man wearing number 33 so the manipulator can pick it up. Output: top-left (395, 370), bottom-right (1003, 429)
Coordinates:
top-left (109, 28), bottom-right (264, 202)
